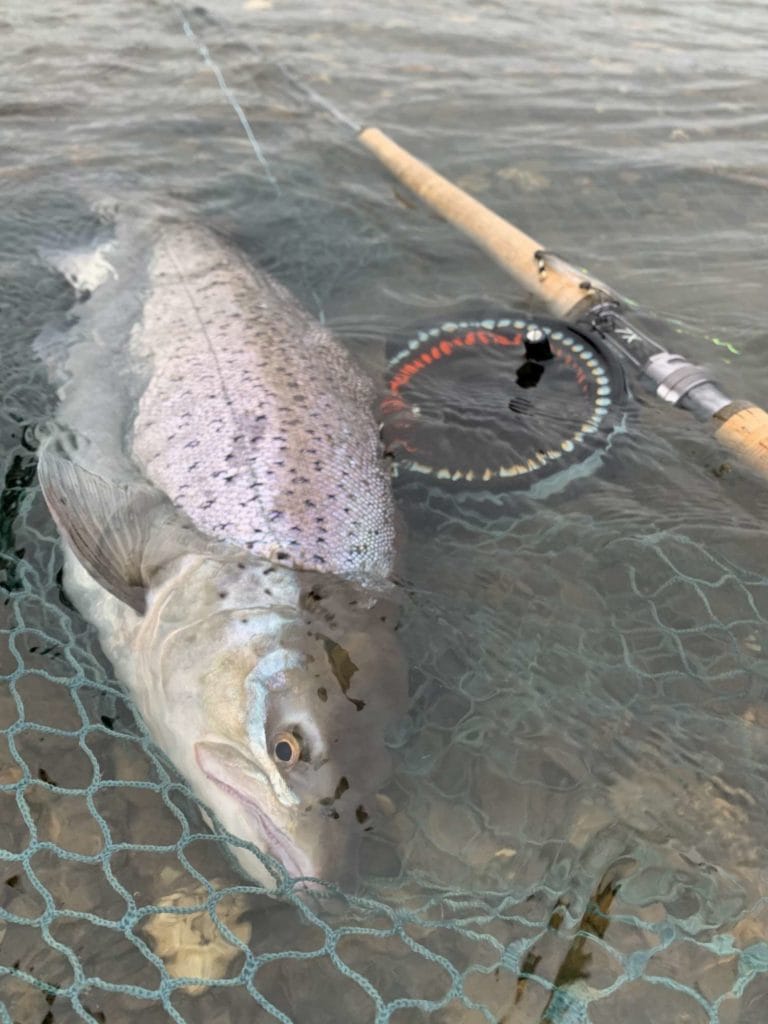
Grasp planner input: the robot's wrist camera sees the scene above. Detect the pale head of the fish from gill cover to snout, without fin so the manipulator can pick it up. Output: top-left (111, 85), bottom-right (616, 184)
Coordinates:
top-left (144, 570), bottom-right (408, 885)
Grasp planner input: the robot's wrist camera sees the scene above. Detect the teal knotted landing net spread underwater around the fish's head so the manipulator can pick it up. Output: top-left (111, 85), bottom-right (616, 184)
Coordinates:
top-left (0, 317), bottom-right (768, 1024)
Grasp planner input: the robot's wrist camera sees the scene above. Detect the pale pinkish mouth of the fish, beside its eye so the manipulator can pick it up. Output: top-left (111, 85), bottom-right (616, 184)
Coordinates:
top-left (195, 742), bottom-right (316, 879)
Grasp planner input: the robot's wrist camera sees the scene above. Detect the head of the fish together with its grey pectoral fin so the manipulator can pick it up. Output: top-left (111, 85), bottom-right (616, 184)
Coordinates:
top-left (38, 435), bottom-right (408, 885)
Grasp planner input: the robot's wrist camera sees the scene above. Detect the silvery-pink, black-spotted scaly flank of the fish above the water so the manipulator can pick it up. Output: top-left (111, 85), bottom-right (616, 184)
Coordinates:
top-left (131, 225), bottom-right (395, 581)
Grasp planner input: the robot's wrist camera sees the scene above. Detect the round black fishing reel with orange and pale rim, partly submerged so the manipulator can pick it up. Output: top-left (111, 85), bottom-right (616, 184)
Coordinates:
top-left (380, 312), bottom-right (626, 493)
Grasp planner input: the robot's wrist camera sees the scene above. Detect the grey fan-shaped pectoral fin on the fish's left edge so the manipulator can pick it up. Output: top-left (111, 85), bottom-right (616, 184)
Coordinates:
top-left (38, 441), bottom-right (177, 613)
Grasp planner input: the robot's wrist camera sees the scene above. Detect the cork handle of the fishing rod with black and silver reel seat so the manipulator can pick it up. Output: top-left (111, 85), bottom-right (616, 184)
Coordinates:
top-left (357, 127), bottom-right (768, 477)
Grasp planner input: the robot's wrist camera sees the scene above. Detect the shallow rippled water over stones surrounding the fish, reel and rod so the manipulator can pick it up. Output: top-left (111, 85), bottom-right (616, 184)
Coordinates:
top-left (0, 0), bottom-right (768, 1024)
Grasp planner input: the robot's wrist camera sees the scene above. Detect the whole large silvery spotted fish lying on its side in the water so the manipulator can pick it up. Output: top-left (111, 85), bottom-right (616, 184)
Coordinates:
top-left (38, 221), bottom-right (408, 886)
